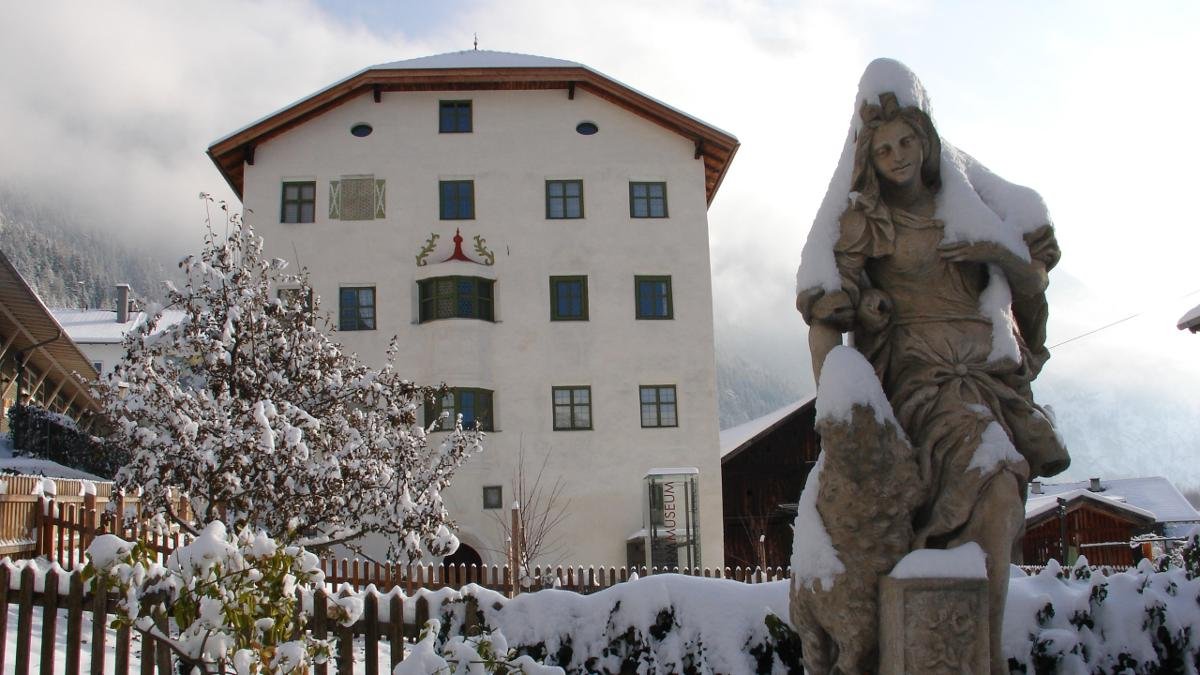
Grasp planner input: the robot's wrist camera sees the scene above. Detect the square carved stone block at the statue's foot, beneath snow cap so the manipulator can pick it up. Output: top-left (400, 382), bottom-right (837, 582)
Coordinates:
top-left (880, 577), bottom-right (989, 675)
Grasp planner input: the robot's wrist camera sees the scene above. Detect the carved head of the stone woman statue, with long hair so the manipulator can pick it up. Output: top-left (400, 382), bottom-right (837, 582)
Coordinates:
top-left (852, 91), bottom-right (942, 202)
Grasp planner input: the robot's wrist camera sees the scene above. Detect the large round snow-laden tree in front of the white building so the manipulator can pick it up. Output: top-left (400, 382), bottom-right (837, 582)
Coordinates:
top-left (96, 198), bottom-right (482, 560)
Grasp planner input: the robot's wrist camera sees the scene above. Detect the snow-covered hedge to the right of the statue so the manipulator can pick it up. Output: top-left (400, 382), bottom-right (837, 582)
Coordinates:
top-left (1004, 552), bottom-right (1200, 675)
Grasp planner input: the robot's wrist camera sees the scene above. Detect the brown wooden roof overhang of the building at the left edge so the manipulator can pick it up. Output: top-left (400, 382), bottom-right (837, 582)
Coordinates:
top-left (0, 253), bottom-right (100, 412)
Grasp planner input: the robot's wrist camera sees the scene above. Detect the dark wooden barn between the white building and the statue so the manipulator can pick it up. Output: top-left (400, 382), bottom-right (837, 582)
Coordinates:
top-left (721, 398), bottom-right (818, 567)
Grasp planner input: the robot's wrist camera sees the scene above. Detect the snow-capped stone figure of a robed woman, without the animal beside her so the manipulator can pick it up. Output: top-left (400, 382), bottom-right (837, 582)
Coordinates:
top-left (793, 60), bottom-right (1069, 673)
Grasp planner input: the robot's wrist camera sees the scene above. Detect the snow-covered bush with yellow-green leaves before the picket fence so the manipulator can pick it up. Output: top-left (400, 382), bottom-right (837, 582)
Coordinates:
top-left (84, 521), bottom-right (350, 675)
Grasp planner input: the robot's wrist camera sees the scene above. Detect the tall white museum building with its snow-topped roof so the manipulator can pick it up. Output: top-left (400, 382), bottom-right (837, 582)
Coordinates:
top-left (209, 50), bottom-right (738, 566)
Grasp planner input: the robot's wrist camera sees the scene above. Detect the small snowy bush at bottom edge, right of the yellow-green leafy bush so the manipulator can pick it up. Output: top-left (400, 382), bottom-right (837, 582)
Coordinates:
top-left (391, 619), bottom-right (564, 675)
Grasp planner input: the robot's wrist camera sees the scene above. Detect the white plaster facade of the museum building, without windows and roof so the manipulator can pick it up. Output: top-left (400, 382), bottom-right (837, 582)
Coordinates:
top-left (235, 86), bottom-right (724, 566)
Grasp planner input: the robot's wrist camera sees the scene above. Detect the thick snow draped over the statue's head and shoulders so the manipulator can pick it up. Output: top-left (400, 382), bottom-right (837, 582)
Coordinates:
top-left (796, 59), bottom-right (1050, 292)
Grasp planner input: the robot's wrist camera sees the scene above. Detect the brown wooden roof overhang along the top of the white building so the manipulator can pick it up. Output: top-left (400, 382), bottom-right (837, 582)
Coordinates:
top-left (208, 66), bottom-right (739, 204)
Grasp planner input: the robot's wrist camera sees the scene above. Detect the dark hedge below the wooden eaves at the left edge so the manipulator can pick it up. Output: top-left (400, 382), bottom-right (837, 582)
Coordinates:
top-left (8, 405), bottom-right (130, 478)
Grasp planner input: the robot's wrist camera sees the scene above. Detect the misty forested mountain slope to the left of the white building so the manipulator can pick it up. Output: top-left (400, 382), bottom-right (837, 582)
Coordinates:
top-left (0, 186), bottom-right (179, 309)
